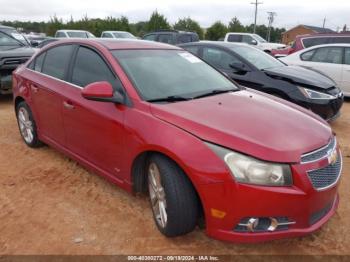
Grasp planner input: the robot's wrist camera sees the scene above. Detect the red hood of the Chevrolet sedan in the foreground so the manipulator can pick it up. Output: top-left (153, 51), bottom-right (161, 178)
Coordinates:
top-left (151, 90), bottom-right (332, 163)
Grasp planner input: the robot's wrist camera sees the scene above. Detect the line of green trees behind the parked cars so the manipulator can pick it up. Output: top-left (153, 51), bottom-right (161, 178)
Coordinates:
top-left (0, 11), bottom-right (285, 42)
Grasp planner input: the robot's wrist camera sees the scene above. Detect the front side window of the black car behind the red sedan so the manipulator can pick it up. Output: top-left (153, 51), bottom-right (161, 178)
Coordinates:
top-left (203, 47), bottom-right (240, 70)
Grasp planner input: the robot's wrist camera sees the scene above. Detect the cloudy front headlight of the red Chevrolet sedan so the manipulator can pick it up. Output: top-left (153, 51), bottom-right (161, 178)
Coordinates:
top-left (206, 143), bottom-right (293, 186)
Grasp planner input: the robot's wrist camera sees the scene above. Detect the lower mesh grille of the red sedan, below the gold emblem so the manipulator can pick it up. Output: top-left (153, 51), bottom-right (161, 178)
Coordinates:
top-left (307, 155), bottom-right (342, 190)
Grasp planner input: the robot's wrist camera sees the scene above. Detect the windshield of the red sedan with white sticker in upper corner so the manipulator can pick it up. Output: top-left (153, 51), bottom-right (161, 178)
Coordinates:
top-left (112, 50), bottom-right (239, 100)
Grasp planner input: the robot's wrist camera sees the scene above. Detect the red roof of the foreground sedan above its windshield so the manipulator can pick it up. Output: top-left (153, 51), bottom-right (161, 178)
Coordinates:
top-left (45, 38), bottom-right (181, 50)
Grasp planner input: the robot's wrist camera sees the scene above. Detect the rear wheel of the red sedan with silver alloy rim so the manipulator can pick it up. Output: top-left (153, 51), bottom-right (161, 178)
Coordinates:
top-left (16, 101), bottom-right (43, 148)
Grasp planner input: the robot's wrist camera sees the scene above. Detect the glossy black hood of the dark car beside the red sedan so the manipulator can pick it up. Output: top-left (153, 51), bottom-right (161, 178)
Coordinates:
top-left (263, 66), bottom-right (335, 89)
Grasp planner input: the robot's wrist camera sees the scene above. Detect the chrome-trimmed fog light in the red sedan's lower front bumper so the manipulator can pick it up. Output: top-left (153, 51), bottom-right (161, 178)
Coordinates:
top-left (234, 217), bottom-right (295, 233)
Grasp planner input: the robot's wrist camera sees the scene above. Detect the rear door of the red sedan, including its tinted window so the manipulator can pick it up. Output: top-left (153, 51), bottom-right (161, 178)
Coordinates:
top-left (29, 45), bottom-right (74, 146)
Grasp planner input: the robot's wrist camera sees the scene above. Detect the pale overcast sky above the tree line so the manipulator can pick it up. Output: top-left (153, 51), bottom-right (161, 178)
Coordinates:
top-left (0, 0), bottom-right (350, 29)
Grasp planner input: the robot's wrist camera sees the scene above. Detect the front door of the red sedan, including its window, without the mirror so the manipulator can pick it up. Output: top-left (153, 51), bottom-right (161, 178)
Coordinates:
top-left (63, 46), bottom-right (125, 178)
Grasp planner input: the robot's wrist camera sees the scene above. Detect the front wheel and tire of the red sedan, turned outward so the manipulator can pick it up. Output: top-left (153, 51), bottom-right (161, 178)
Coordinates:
top-left (146, 155), bottom-right (199, 237)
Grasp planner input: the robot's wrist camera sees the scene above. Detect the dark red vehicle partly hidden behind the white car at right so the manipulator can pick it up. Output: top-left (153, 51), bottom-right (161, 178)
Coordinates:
top-left (271, 33), bottom-right (350, 57)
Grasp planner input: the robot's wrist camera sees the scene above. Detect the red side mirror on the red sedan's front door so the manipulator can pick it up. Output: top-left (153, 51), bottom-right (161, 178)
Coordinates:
top-left (81, 81), bottom-right (124, 104)
